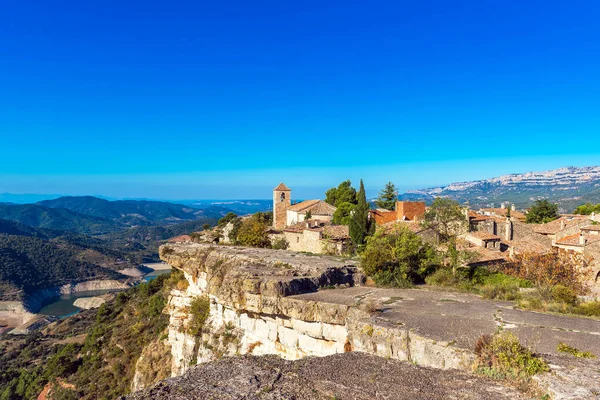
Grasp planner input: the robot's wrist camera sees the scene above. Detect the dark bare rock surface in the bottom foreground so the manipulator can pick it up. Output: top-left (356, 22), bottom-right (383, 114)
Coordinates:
top-left (127, 353), bottom-right (528, 400)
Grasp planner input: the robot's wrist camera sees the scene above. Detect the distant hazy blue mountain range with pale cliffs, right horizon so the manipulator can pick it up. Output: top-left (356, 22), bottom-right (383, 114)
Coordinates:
top-left (400, 166), bottom-right (600, 212)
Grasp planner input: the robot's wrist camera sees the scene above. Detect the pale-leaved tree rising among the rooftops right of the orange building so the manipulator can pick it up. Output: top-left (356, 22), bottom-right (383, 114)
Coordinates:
top-left (421, 197), bottom-right (468, 242)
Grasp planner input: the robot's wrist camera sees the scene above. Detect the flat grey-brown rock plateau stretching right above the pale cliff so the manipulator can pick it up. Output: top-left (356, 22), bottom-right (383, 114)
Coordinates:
top-left (291, 286), bottom-right (600, 357)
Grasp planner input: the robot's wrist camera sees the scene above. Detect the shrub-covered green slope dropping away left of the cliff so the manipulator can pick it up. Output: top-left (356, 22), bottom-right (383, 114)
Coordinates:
top-left (0, 272), bottom-right (183, 400)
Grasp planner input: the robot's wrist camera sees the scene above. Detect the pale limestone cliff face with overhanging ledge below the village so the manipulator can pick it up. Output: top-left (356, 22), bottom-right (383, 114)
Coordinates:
top-left (160, 244), bottom-right (470, 376)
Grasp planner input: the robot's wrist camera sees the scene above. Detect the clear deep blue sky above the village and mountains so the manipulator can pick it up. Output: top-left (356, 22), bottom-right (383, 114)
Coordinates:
top-left (0, 0), bottom-right (600, 199)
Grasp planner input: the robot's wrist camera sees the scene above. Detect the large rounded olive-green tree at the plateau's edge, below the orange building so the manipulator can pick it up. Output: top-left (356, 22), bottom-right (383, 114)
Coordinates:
top-left (361, 227), bottom-right (439, 287)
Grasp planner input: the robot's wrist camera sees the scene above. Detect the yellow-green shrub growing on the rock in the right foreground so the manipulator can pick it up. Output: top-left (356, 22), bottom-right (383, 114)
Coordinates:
top-left (474, 332), bottom-right (550, 381)
